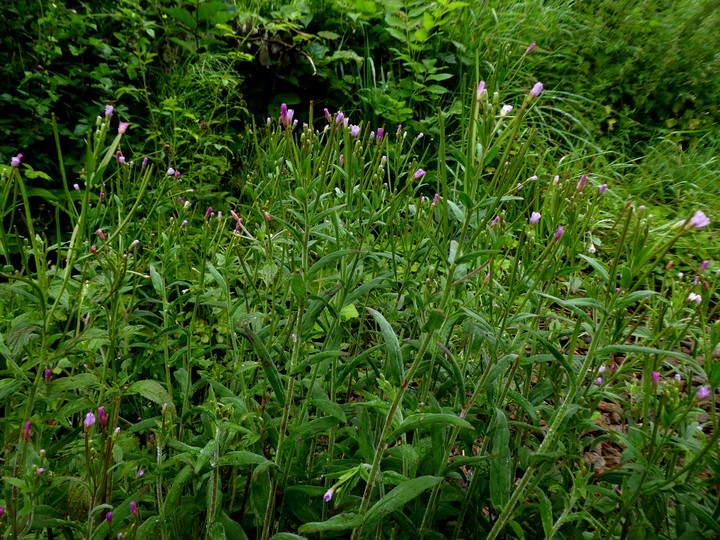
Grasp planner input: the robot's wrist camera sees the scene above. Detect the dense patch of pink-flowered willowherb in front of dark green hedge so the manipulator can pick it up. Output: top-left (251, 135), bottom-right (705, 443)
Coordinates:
top-left (0, 73), bottom-right (720, 540)
